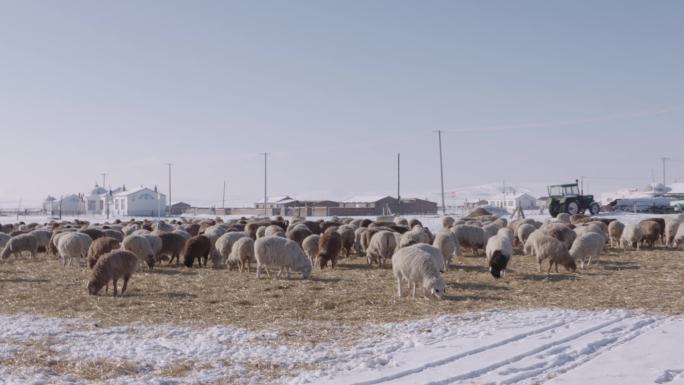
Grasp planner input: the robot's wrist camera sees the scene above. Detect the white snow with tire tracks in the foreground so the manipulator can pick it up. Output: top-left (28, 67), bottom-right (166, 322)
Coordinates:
top-left (0, 309), bottom-right (684, 385)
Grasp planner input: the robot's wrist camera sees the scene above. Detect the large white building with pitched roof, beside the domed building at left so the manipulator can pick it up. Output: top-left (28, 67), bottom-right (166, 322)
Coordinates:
top-left (109, 187), bottom-right (166, 217)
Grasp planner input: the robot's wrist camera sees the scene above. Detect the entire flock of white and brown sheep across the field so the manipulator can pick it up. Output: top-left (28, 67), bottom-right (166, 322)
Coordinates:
top-left (0, 210), bottom-right (684, 298)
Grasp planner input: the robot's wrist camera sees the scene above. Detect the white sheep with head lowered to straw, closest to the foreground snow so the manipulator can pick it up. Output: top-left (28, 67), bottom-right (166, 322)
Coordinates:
top-left (392, 245), bottom-right (445, 298)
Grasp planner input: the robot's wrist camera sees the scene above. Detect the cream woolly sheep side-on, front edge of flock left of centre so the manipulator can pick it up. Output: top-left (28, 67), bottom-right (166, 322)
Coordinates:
top-left (254, 236), bottom-right (312, 279)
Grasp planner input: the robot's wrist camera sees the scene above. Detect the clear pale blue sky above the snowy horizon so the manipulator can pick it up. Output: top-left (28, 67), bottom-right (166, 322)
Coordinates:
top-left (0, 0), bottom-right (684, 207)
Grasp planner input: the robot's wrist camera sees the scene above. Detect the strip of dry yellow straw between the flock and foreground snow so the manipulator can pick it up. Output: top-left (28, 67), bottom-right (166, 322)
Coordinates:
top-left (0, 249), bottom-right (684, 332)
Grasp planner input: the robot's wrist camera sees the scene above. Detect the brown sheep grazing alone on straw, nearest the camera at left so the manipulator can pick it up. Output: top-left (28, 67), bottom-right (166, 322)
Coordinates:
top-left (88, 250), bottom-right (138, 297)
